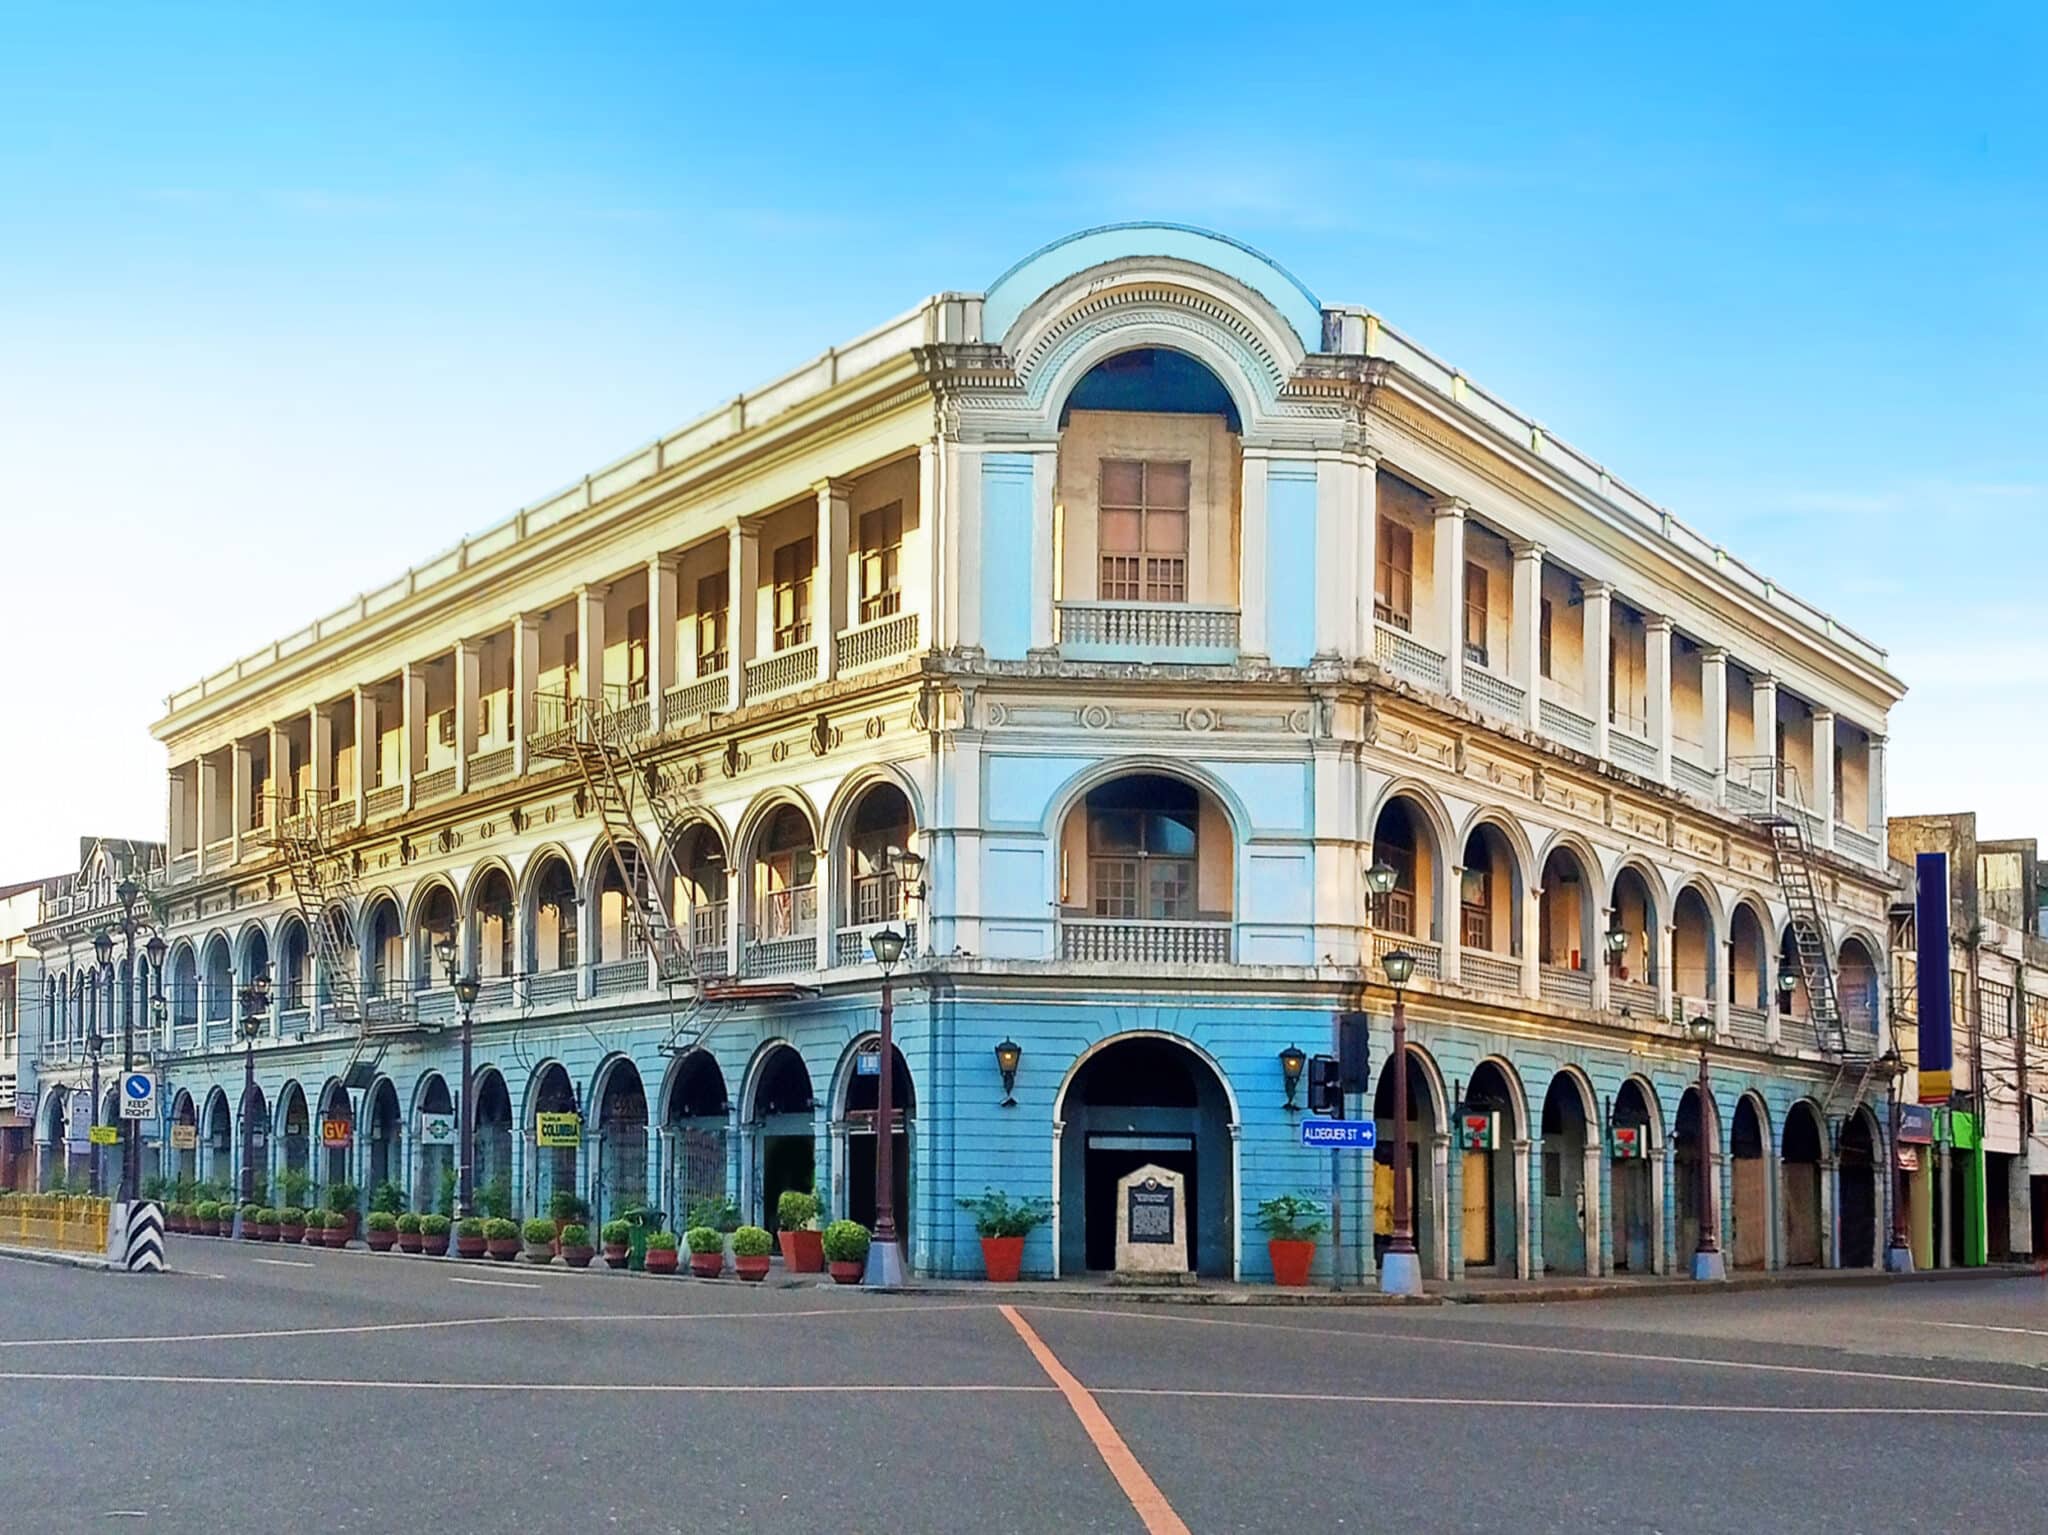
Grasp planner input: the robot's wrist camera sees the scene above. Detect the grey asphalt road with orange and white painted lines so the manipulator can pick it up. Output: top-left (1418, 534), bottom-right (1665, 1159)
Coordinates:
top-left (0, 1238), bottom-right (2048, 1535)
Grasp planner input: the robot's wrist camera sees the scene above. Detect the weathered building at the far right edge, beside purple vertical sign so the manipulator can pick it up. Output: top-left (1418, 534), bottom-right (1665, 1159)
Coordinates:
top-left (1890, 813), bottom-right (2048, 1269)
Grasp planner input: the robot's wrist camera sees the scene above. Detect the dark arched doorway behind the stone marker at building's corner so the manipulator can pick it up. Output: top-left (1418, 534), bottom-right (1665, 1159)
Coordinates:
top-left (1053, 1034), bottom-right (1237, 1279)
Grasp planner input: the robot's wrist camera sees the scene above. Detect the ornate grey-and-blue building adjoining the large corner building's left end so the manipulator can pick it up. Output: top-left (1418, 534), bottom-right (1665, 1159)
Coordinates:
top-left (23, 837), bottom-right (164, 1193)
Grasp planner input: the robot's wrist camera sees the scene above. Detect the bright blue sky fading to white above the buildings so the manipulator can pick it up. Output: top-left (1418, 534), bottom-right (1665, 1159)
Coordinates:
top-left (0, 2), bottom-right (2048, 882)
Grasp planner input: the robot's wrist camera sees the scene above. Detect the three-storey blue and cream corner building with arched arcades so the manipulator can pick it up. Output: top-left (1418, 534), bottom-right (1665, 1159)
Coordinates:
top-left (128, 225), bottom-right (1901, 1279)
